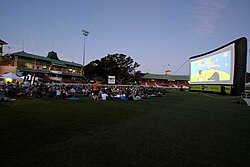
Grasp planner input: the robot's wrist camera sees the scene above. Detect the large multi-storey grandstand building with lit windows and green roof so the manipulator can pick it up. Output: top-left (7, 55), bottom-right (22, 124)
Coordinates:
top-left (0, 51), bottom-right (85, 83)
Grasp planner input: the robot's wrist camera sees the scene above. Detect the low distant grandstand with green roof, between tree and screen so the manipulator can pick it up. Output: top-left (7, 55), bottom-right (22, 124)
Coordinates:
top-left (141, 70), bottom-right (189, 87)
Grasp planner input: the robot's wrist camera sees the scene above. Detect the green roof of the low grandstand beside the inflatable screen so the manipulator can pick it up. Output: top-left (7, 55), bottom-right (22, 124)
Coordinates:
top-left (142, 73), bottom-right (189, 81)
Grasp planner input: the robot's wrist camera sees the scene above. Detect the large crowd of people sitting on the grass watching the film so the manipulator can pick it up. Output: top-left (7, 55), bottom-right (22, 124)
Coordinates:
top-left (0, 83), bottom-right (167, 100)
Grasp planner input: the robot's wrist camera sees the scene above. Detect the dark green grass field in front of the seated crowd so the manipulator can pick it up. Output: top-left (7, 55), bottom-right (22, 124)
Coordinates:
top-left (0, 92), bottom-right (250, 167)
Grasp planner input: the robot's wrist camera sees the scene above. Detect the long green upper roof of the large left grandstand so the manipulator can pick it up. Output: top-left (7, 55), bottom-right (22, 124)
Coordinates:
top-left (11, 51), bottom-right (82, 68)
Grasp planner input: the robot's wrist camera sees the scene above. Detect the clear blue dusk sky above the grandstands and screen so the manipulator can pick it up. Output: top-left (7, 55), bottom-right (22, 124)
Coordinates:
top-left (0, 0), bottom-right (250, 74)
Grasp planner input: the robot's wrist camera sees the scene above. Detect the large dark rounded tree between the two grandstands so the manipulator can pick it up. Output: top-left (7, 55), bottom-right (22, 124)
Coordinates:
top-left (84, 53), bottom-right (140, 84)
